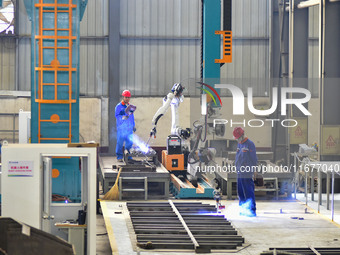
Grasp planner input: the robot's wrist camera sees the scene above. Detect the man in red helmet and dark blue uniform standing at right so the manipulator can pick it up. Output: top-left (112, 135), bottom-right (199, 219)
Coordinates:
top-left (233, 127), bottom-right (257, 217)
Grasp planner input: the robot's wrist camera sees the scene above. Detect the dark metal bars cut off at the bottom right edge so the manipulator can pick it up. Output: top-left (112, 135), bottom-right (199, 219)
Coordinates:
top-left (261, 247), bottom-right (340, 255)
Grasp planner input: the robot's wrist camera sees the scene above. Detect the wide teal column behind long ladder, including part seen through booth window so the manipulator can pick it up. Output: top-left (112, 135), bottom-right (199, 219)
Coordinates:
top-left (24, 0), bottom-right (87, 202)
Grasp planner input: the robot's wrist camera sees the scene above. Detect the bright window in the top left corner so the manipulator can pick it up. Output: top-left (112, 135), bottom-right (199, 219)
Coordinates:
top-left (0, 0), bottom-right (16, 36)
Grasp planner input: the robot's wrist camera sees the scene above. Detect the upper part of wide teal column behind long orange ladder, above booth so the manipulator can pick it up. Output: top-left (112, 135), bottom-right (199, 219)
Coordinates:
top-left (24, 0), bottom-right (87, 143)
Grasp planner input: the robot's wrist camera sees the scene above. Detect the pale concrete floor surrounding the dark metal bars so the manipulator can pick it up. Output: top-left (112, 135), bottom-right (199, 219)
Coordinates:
top-left (97, 199), bottom-right (340, 255)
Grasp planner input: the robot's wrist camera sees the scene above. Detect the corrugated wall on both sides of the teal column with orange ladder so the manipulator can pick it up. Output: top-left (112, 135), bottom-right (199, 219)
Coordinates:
top-left (0, 0), bottom-right (108, 97)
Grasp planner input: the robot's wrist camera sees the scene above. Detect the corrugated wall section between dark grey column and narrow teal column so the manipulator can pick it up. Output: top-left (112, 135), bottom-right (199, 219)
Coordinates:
top-left (120, 0), bottom-right (201, 96)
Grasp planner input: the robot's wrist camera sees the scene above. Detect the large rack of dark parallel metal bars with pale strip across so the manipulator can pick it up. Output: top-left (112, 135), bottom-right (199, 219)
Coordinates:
top-left (127, 201), bottom-right (244, 252)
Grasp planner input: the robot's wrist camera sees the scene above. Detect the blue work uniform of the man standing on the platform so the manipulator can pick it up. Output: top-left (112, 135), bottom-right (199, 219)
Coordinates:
top-left (115, 101), bottom-right (135, 159)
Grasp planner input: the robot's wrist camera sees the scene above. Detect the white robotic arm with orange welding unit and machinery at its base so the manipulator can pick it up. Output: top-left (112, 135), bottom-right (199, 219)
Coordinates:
top-left (150, 83), bottom-right (219, 189)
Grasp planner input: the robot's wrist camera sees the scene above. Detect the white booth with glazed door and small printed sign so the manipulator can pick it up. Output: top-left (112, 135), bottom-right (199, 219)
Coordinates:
top-left (1, 144), bottom-right (97, 255)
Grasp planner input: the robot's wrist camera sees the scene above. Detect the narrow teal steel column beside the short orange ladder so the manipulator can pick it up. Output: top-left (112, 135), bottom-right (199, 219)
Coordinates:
top-left (202, 0), bottom-right (221, 85)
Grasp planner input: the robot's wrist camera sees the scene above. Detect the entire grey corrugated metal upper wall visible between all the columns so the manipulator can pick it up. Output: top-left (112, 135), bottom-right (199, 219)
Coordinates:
top-left (0, 0), bottom-right (319, 96)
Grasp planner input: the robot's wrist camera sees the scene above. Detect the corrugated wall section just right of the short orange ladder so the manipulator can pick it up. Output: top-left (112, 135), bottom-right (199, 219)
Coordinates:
top-left (221, 0), bottom-right (270, 96)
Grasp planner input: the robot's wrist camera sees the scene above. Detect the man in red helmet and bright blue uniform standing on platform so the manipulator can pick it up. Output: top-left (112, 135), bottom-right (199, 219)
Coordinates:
top-left (115, 90), bottom-right (136, 162)
